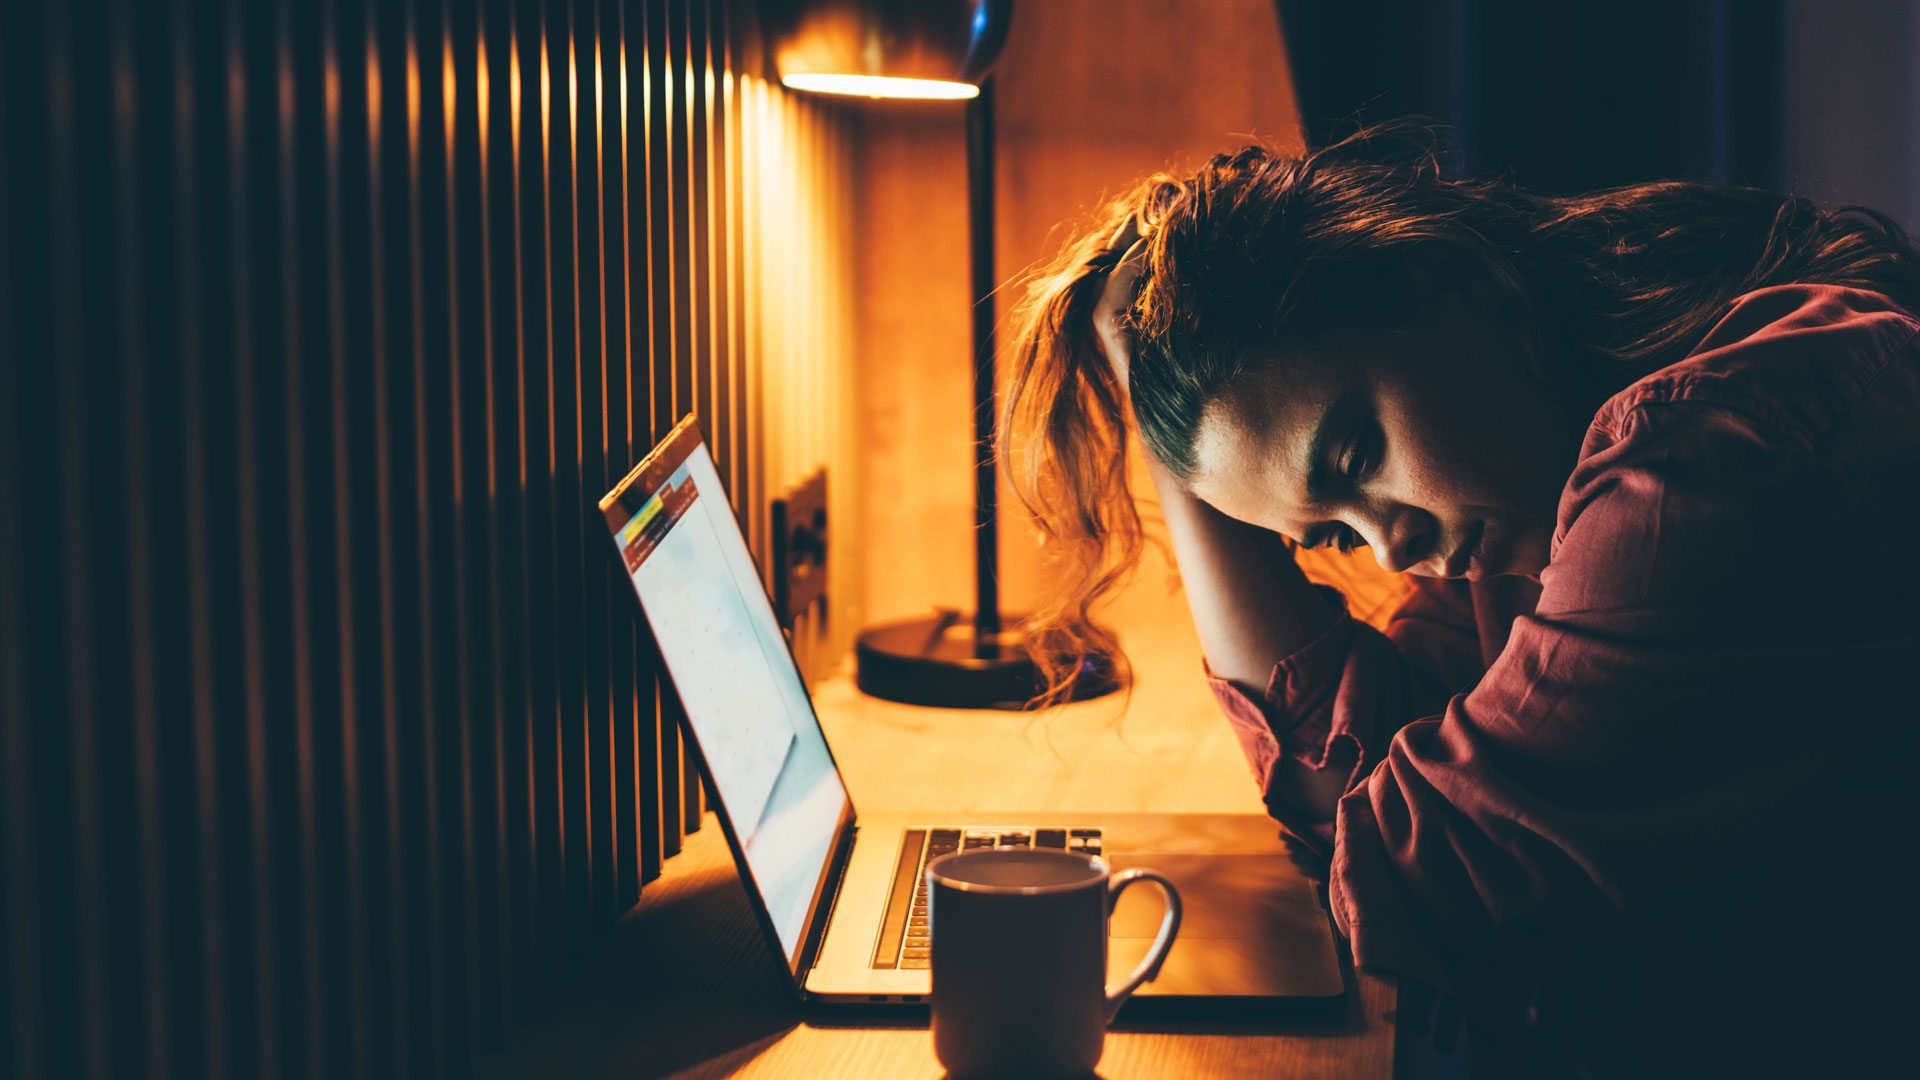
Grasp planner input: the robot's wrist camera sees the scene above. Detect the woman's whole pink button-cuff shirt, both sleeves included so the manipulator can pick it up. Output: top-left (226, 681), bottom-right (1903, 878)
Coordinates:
top-left (1212, 284), bottom-right (1920, 1060)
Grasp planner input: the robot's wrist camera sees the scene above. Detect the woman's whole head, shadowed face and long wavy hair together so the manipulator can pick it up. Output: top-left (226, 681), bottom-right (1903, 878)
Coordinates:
top-left (1002, 127), bottom-right (1920, 703)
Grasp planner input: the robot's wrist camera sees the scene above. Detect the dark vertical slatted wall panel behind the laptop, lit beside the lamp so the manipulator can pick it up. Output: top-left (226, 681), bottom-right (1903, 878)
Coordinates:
top-left (0, 0), bottom-right (858, 1078)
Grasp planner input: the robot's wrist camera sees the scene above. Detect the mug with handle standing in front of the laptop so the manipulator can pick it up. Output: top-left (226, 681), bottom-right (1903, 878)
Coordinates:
top-left (927, 847), bottom-right (1181, 1080)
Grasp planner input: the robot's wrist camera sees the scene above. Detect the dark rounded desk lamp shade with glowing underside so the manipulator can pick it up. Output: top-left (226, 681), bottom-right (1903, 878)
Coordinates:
top-left (762, 0), bottom-right (1014, 98)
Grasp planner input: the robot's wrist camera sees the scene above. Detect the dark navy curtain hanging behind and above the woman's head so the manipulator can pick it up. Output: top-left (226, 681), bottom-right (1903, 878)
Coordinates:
top-left (1275, 0), bottom-right (1784, 194)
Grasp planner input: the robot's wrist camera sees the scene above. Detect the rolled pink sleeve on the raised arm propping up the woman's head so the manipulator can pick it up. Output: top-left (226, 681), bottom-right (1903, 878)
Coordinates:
top-left (1208, 578), bottom-right (1482, 855)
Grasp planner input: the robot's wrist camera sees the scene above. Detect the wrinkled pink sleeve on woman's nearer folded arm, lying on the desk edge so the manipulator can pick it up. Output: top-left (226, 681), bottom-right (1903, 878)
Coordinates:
top-left (1331, 402), bottom-right (1912, 1022)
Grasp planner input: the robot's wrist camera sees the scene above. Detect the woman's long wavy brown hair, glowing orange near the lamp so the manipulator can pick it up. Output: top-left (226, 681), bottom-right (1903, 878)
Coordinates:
top-left (1000, 123), bottom-right (1920, 703)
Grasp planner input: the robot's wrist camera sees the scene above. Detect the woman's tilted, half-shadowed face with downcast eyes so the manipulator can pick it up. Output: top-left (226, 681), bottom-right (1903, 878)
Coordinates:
top-left (1188, 294), bottom-right (1580, 578)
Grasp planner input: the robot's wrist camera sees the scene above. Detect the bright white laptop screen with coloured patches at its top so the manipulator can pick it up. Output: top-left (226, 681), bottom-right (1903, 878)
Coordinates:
top-left (601, 425), bottom-right (847, 953)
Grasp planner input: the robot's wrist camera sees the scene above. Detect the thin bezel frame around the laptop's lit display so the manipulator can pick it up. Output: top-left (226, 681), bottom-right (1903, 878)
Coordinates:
top-left (599, 413), bottom-right (856, 997)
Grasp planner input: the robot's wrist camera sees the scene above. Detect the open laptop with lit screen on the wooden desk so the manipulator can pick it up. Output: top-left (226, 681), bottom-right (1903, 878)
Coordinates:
top-left (599, 417), bottom-right (1344, 1009)
